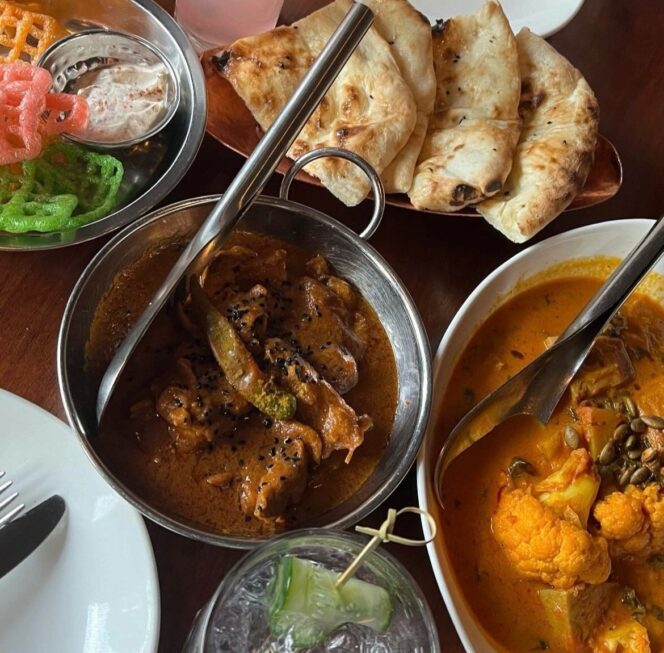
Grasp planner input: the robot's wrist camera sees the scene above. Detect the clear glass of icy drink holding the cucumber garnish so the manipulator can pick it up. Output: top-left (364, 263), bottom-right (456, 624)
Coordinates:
top-left (184, 529), bottom-right (440, 653)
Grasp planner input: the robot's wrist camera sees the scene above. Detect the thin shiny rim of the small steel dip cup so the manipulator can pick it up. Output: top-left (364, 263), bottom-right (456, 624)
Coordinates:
top-left (37, 27), bottom-right (181, 150)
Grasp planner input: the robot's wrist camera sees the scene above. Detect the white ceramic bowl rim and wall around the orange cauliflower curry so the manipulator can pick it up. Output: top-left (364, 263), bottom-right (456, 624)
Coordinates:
top-left (417, 220), bottom-right (664, 653)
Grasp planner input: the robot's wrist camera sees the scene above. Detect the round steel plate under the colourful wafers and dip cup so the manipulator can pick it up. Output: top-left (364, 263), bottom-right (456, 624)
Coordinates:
top-left (0, 0), bottom-right (207, 250)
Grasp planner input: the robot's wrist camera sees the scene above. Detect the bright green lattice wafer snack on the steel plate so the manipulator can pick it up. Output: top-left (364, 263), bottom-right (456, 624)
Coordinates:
top-left (0, 143), bottom-right (124, 233)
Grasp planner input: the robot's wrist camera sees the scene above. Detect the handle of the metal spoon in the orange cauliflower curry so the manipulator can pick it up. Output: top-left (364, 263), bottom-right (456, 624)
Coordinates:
top-left (559, 219), bottom-right (664, 340)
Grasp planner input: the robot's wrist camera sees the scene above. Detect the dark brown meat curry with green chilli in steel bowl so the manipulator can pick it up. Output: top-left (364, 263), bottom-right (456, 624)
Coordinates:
top-left (87, 232), bottom-right (397, 537)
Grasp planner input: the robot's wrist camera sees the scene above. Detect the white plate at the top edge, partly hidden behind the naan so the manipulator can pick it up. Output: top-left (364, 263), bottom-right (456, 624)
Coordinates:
top-left (410, 0), bottom-right (583, 36)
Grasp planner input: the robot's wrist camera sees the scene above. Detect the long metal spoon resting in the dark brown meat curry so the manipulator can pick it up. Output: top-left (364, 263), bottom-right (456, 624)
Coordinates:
top-left (97, 3), bottom-right (373, 423)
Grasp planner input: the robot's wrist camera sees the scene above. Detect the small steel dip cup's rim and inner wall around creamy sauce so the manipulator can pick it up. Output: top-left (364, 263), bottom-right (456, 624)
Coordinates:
top-left (37, 29), bottom-right (180, 150)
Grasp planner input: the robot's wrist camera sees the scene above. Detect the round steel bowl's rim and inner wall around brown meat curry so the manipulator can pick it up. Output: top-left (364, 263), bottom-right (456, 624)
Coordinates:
top-left (58, 196), bottom-right (431, 548)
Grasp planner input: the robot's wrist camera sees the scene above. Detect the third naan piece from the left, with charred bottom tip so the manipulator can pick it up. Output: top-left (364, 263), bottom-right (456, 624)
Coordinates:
top-left (408, 0), bottom-right (520, 211)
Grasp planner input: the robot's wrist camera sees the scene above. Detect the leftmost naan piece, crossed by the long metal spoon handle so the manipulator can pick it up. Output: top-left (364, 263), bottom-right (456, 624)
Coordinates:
top-left (215, 0), bottom-right (417, 206)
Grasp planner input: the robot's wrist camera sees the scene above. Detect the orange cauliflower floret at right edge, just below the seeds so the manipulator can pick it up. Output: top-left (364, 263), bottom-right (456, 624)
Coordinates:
top-left (593, 484), bottom-right (664, 557)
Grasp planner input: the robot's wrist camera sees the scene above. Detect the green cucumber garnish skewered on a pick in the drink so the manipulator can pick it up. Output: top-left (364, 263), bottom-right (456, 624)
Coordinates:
top-left (268, 556), bottom-right (392, 648)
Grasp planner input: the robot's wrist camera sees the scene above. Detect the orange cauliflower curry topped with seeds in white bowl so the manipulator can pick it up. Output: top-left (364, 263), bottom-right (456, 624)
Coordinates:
top-left (437, 264), bottom-right (664, 653)
